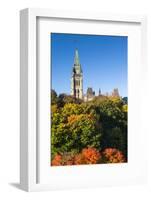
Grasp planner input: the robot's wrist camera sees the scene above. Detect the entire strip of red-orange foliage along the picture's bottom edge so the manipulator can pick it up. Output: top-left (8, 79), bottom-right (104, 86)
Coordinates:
top-left (51, 147), bottom-right (125, 166)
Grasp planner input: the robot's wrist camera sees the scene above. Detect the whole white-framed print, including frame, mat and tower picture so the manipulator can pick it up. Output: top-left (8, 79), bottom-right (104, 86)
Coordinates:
top-left (20, 9), bottom-right (147, 191)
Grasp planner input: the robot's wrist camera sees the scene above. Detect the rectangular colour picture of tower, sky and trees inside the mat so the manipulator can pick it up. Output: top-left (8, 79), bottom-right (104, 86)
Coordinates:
top-left (48, 32), bottom-right (128, 167)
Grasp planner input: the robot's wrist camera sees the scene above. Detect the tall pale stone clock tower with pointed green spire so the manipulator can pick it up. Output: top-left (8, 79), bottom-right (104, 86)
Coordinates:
top-left (71, 49), bottom-right (83, 99)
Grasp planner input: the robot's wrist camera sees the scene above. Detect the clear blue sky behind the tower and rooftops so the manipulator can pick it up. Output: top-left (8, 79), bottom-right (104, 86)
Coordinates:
top-left (50, 33), bottom-right (128, 97)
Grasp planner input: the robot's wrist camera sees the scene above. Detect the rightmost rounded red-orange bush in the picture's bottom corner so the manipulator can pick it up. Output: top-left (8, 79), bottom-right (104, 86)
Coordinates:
top-left (102, 148), bottom-right (125, 163)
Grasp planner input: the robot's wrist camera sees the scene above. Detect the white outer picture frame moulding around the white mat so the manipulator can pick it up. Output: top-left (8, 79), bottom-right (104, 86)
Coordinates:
top-left (20, 8), bottom-right (147, 191)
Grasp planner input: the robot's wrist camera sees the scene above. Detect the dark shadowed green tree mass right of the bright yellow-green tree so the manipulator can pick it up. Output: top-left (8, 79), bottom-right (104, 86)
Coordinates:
top-left (95, 99), bottom-right (127, 157)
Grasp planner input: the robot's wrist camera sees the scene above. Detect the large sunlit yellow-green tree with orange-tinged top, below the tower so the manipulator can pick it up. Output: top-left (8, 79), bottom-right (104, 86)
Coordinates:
top-left (51, 104), bottom-right (101, 158)
